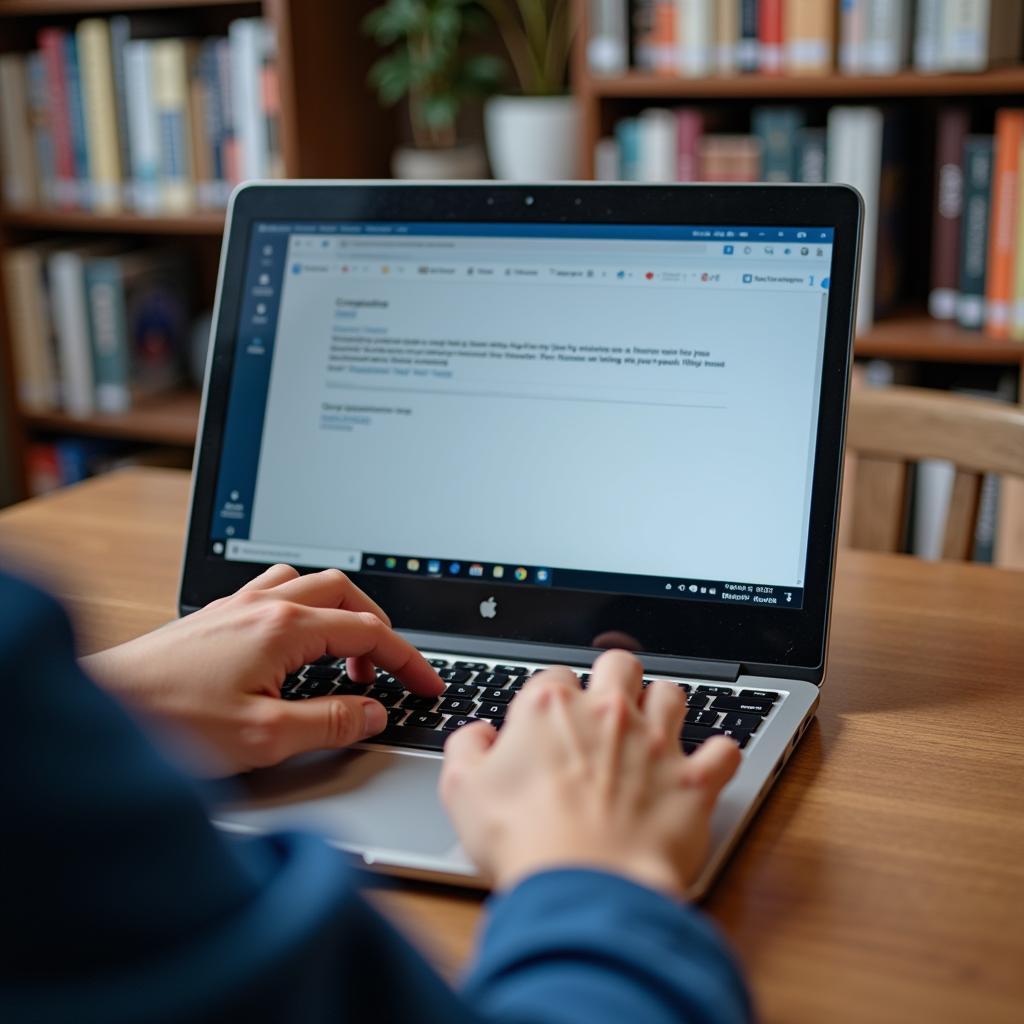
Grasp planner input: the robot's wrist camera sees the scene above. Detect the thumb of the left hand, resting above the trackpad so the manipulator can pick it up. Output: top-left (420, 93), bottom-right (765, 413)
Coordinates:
top-left (266, 696), bottom-right (387, 763)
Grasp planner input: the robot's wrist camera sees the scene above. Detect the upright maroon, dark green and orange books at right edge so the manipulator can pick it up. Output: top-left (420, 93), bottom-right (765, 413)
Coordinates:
top-left (929, 108), bottom-right (1024, 341)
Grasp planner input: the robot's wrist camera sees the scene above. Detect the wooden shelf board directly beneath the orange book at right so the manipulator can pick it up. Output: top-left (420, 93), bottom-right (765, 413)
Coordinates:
top-left (854, 314), bottom-right (1024, 366)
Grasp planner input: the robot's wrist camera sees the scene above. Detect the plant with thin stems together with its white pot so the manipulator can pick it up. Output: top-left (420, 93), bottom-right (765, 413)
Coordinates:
top-left (480, 0), bottom-right (580, 181)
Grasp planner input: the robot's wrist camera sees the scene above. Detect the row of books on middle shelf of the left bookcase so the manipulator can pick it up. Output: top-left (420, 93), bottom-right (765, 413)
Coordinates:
top-left (3, 242), bottom-right (189, 417)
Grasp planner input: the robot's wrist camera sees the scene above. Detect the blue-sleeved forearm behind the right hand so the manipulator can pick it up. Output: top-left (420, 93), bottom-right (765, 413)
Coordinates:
top-left (464, 870), bottom-right (752, 1024)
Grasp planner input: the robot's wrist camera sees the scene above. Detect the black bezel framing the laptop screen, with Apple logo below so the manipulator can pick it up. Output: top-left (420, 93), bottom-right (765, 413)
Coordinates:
top-left (179, 182), bottom-right (861, 679)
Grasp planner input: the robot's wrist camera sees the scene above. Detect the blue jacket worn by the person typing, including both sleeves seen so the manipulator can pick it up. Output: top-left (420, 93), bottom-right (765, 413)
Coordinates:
top-left (0, 575), bottom-right (751, 1024)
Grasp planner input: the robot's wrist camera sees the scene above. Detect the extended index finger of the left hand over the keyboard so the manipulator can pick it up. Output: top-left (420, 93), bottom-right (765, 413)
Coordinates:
top-left (307, 607), bottom-right (444, 696)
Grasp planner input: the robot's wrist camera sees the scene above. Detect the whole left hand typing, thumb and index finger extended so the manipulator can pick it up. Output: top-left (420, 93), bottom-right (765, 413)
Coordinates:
top-left (82, 565), bottom-right (443, 771)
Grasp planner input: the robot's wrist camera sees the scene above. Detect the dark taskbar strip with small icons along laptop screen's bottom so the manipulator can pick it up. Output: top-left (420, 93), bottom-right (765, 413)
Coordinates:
top-left (360, 552), bottom-right (804, 609)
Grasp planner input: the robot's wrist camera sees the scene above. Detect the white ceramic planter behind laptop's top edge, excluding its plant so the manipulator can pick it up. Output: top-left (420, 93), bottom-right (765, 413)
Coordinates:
top-left (483, 96), bottom-right (580, 181)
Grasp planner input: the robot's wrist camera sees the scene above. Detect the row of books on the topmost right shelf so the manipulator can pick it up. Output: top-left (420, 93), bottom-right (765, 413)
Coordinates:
top-left (587, 0), bottom-right (1022, 77)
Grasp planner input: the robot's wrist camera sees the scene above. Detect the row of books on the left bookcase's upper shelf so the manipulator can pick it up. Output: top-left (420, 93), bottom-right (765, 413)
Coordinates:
top-left (0, 15), bottom-right (284, 214)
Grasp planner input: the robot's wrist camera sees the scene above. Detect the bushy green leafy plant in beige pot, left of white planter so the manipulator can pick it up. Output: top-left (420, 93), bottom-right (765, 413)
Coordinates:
top-left (362, 0), bottom-right (504, 179)
